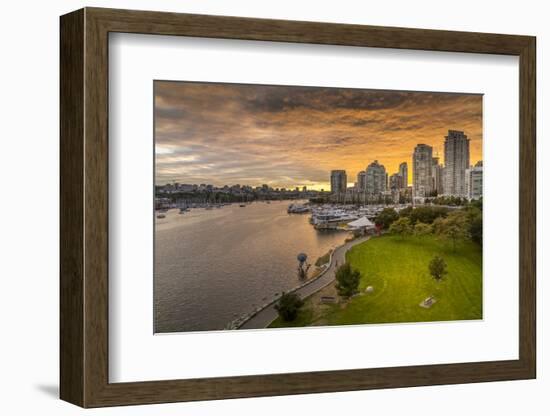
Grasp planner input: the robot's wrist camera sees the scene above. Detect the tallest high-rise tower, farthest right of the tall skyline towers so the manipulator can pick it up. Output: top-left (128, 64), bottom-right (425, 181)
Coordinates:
top-left (443, 130), bottom-right (470, 196)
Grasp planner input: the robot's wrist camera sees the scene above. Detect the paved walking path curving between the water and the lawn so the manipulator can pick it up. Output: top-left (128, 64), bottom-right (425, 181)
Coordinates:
top-left (238, 236), bottom-right (370, 329)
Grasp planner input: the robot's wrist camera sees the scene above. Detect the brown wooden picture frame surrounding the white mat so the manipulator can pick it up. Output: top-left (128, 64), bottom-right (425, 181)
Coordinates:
top-left (60, 8), bottom-right (536, 407)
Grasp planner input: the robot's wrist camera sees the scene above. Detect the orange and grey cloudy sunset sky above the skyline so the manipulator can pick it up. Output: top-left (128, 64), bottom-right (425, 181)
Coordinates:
top-left (155, 81), bottom-right (482, 190)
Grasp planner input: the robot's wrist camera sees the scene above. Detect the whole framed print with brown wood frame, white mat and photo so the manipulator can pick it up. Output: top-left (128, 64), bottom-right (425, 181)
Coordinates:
top-left (60, 8), bottom-right (536, 407)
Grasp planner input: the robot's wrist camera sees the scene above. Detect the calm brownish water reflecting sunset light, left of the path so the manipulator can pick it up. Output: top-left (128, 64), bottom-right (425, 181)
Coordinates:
top-left (154, 202), bottom-right (347, 332)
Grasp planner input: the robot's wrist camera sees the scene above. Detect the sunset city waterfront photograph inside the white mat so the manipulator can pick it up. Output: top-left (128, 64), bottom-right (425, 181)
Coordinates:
top-left (151, 80), bottom-right (483, 334)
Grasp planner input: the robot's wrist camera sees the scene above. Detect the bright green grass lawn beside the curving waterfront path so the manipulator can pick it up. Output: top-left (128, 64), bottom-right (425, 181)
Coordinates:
top-left (271, 235), bottom-right (482, 327)
